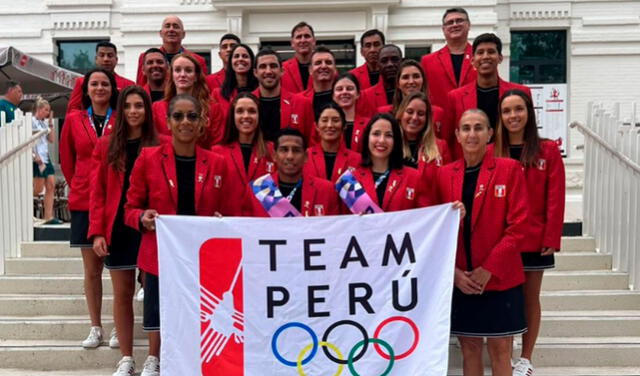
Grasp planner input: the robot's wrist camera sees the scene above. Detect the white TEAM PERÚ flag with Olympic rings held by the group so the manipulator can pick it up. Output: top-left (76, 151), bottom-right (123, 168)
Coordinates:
top-left (157, 205), bottom-right (459, 376)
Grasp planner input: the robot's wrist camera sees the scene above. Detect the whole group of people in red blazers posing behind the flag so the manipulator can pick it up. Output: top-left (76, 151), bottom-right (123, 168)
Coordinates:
top-left (60, 8), bottom-right (565, 376)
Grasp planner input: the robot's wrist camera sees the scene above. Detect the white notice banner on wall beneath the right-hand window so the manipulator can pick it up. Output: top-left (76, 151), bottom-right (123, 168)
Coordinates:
top-left (527, 84), bottom-right (569, 156)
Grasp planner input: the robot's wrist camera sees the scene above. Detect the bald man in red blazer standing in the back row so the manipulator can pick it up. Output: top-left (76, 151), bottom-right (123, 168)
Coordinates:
top-left (136, 16), bottom-right (209, 86)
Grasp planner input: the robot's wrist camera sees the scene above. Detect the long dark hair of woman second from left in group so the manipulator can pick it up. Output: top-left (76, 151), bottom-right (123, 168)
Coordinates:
top-left (107, 86), bottom-right (158, 171)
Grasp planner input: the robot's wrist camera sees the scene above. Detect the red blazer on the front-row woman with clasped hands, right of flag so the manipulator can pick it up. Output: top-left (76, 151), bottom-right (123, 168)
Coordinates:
top-left (436, 152), bottom-right (529, 290)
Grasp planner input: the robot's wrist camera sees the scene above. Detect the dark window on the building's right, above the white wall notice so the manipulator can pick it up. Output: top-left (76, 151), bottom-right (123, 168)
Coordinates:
top-left (510, 30), bottom-right (567, 84)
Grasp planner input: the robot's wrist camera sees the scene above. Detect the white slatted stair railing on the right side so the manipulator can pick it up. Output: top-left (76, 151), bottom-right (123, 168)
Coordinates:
top-left (570, 103), bottom-right (640, 290)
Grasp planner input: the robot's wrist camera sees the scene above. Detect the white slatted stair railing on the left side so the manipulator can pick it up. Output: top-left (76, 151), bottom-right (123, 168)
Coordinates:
top-left (0, 111), bottom-right (41, 275)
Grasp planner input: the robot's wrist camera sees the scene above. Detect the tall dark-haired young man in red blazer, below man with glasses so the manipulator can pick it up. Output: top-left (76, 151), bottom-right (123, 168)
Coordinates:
top-left (440, 33), bottom-right (531, 160)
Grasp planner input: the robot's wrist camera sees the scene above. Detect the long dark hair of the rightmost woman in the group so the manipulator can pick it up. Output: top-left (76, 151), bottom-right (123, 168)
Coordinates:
top-left (494, 89), bottom-right (542, 167)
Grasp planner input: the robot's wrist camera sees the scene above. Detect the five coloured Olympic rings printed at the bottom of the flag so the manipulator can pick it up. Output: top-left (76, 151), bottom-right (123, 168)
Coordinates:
top-left (271, 316), bottom-right (420, 376)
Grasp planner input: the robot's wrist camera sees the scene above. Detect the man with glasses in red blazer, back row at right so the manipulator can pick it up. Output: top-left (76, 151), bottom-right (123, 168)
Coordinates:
top-left (420, 8), bottom-right (476, 107)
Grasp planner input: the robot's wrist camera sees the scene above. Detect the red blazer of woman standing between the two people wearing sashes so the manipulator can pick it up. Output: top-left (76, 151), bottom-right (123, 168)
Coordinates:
top-left (304, 144), bottom-right (361, 183)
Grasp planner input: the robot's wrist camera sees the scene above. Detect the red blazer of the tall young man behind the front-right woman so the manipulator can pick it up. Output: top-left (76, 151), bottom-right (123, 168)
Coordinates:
top-left (440, 77), bottom-right (531, 160)
